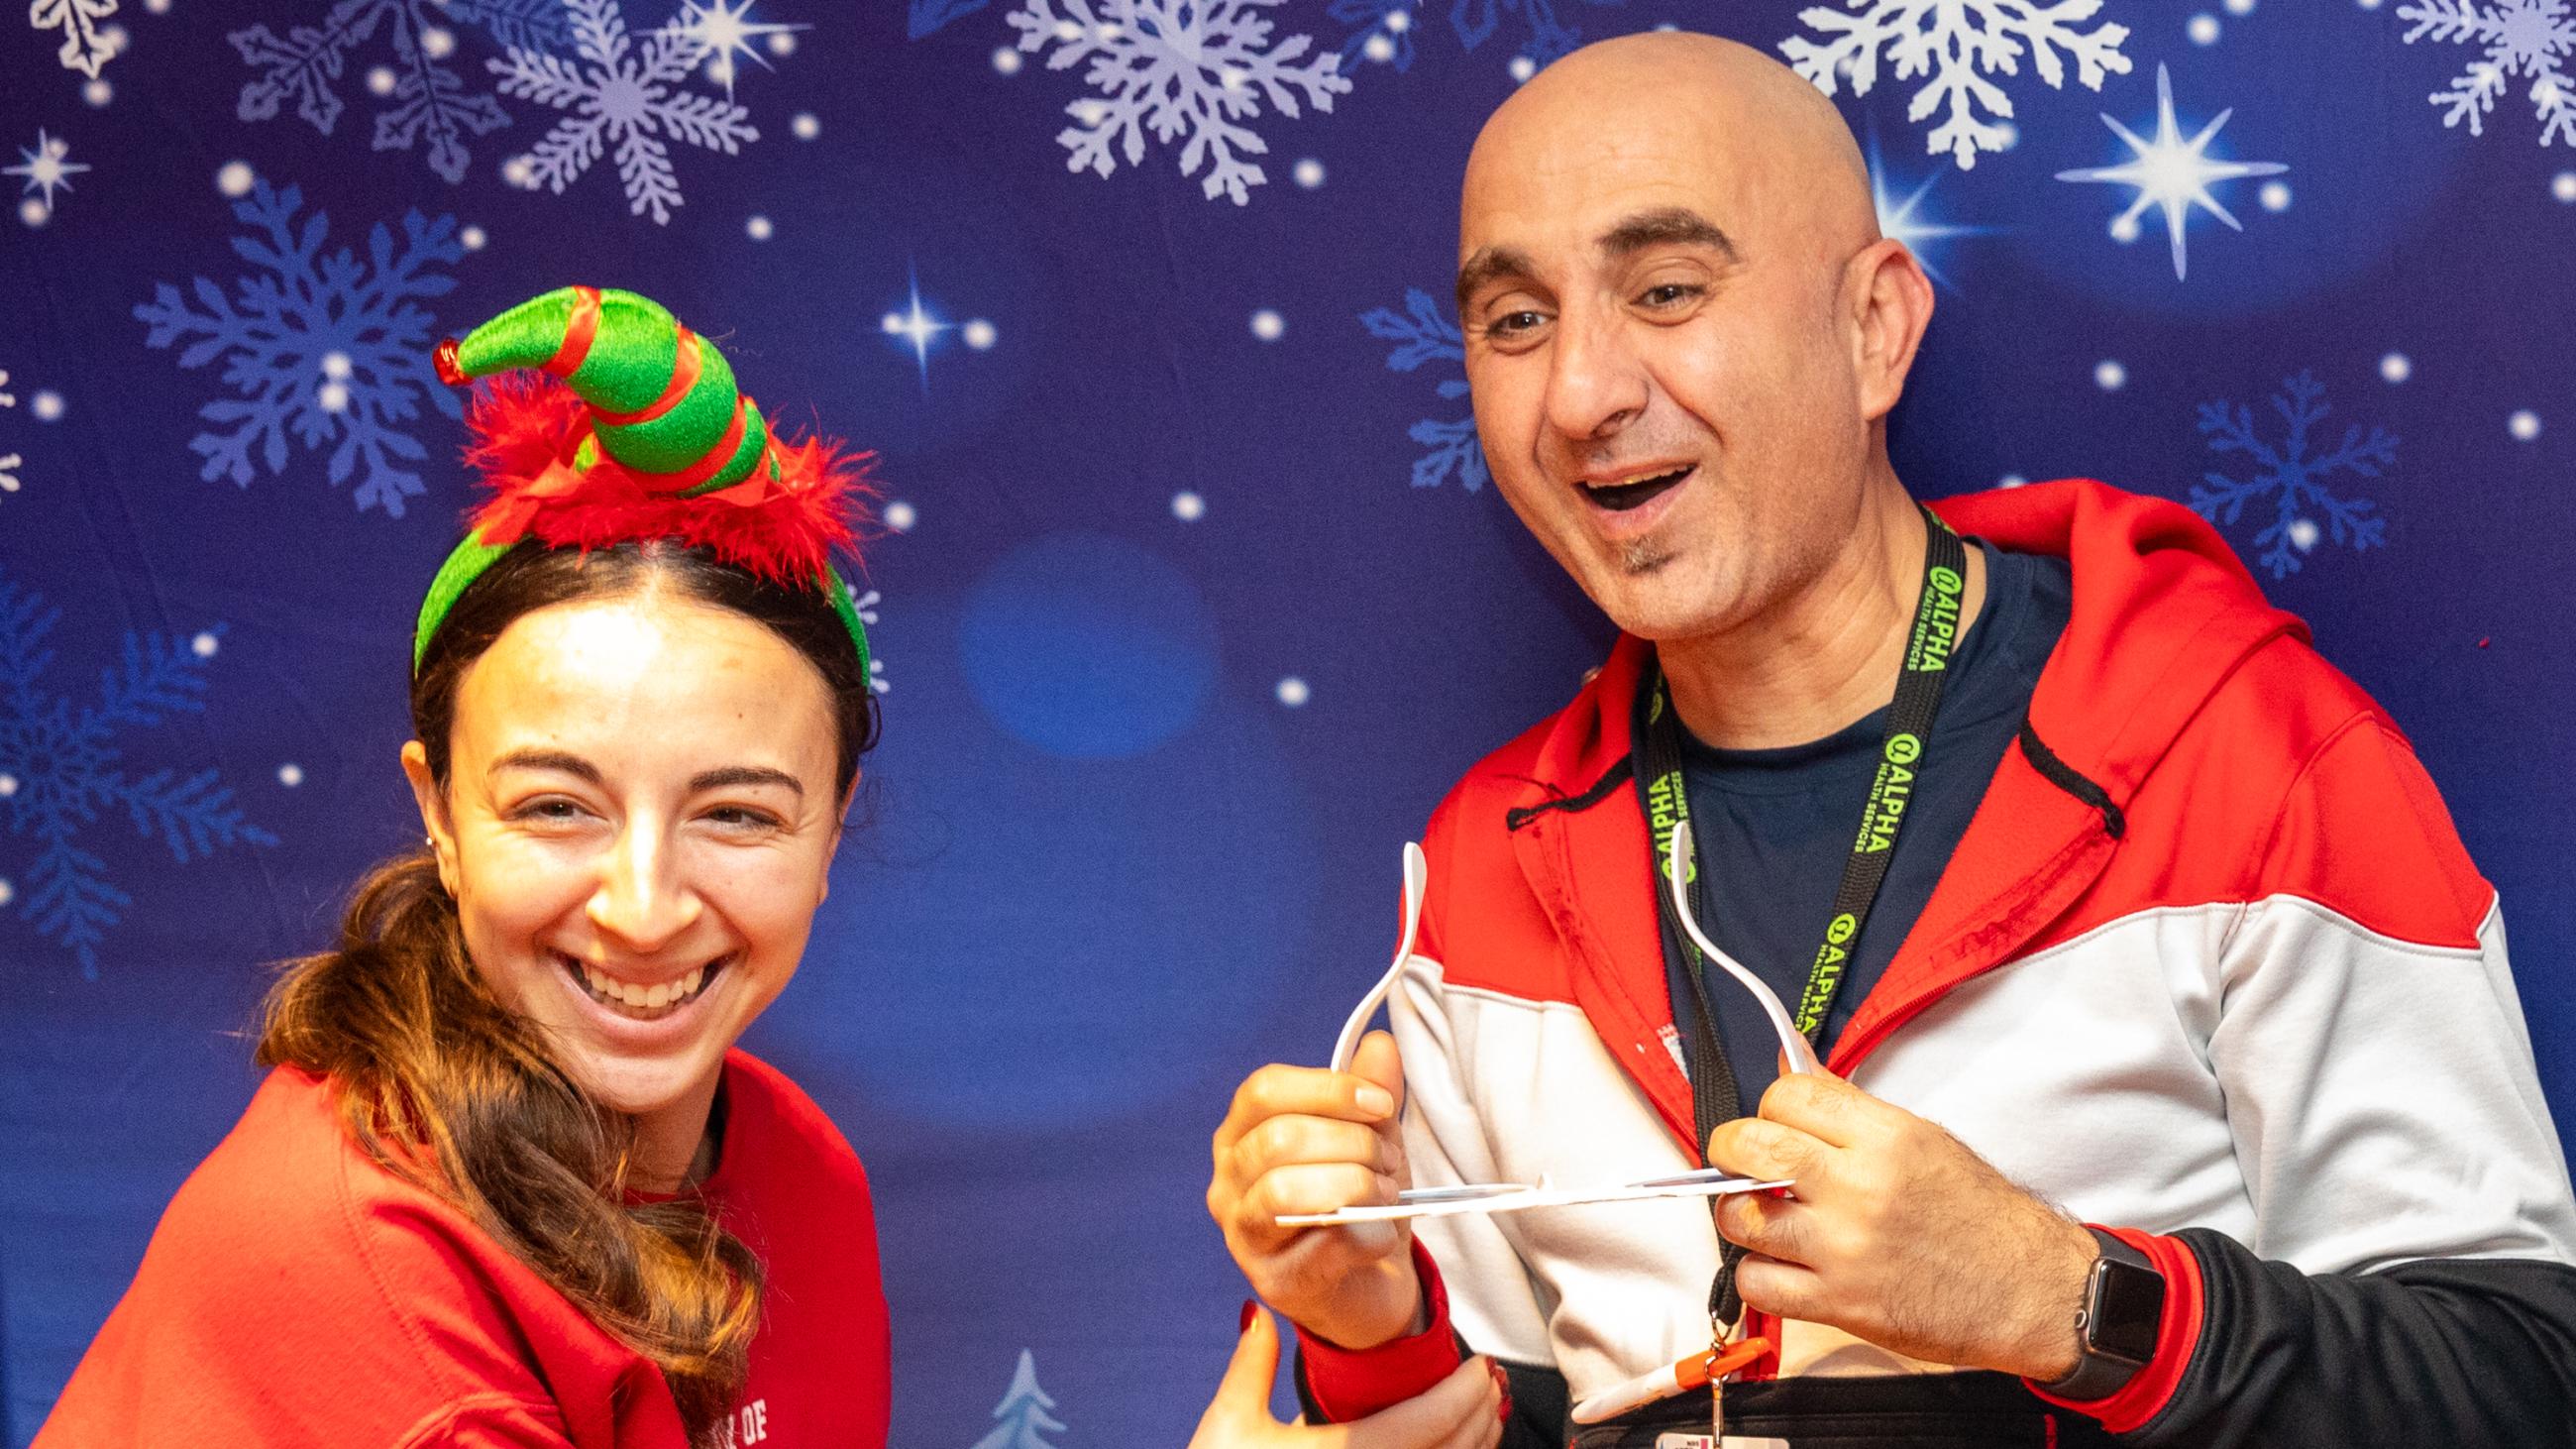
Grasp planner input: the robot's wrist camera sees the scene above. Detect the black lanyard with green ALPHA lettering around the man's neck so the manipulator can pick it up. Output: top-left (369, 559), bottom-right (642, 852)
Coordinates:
top-left (1639, 507), bottom-right (1968, 1336)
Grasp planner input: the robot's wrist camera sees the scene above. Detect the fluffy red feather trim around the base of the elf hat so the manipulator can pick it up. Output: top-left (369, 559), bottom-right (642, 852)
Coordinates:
top-left (464, 374), bottom-right (876, 586)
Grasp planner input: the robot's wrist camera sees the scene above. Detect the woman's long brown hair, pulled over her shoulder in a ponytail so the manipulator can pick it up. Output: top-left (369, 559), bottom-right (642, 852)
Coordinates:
top-left (258, 541), bottom-right (876, 1444)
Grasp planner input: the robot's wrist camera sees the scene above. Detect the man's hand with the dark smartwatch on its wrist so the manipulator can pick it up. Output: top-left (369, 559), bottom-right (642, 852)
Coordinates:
top-left (1708, 1070), bottom-right (2096, 1382)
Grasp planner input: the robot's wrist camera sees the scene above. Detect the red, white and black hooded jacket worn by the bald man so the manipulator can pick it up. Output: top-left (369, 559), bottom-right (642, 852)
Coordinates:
top-left (1304, 480), bottom-right (2576, 1446)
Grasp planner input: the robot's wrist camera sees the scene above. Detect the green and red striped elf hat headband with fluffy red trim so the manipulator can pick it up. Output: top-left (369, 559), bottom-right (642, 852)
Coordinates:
top-left (412, 286), bottom-right (871, 678)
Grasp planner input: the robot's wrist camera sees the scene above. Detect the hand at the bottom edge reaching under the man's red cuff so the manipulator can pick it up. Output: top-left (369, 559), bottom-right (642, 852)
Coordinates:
top-left (1190, 1302), bottom-right (1510, 1449)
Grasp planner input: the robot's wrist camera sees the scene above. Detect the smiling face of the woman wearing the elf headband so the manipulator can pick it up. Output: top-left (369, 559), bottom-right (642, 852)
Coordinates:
top-left (402, 588), bottom-right (845, 1139)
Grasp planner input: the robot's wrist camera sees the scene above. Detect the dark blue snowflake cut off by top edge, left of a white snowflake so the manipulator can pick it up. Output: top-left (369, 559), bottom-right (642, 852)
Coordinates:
top-left (224, 0), bottom-right (567, 183)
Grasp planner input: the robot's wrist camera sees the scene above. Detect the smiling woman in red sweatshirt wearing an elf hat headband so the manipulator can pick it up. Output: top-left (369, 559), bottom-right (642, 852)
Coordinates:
top-left (36, 286), bottom-right (1499, 1449)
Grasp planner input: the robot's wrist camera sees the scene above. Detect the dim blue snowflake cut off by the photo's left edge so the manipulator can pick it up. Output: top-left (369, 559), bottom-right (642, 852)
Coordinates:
top-left (0, 578), bottom-right (278, 977)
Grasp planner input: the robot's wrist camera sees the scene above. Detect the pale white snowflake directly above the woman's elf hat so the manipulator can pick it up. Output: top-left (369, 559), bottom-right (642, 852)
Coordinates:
top-left (486, 0), bottom-right (760, 227)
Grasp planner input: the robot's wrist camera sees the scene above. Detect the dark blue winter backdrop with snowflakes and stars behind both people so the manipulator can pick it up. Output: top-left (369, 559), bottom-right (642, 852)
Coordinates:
top-left (0, 0), bottom-right (2576, 1449)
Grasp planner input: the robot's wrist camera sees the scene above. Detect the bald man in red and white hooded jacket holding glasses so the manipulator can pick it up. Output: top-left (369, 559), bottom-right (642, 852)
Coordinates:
top-left (1208, 34), bottom-right (2576, 1449)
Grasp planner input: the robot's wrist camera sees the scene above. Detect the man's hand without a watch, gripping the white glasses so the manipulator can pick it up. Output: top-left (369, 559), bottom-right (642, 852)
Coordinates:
top-left (1208, 1032), bottom-right (1422, 1349)
